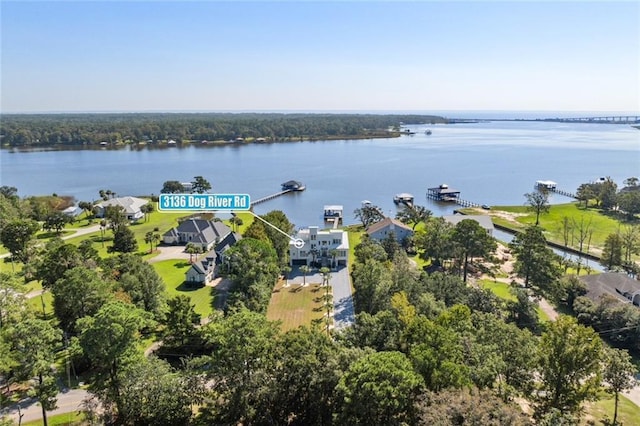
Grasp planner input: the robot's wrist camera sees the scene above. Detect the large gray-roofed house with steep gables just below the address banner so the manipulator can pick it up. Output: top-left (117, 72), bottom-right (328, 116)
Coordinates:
top-left (162, 219), bottom-right (231, 252)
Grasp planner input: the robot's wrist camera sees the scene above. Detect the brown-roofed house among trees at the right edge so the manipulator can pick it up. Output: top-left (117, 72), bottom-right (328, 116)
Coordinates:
top-left (580, 272), bottom-right (640, 306)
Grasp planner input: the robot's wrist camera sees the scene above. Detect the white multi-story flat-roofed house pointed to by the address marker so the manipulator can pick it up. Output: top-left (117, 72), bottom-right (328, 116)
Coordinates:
top-left (289, 226), bottom-right (349, 267)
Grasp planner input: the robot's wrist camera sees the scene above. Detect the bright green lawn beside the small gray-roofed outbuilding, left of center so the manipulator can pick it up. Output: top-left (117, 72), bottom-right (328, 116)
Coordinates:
top-left (153, 259), bottom-right (216, 318)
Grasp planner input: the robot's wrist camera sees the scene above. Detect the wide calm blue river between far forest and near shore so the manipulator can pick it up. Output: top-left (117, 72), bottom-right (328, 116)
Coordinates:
top-left (0, 122), bottom-right (640, 227)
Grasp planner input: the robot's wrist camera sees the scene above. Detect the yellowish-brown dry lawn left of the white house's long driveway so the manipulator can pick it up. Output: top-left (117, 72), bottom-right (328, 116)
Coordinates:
top-left (267, 280), bottom-right (325, 331)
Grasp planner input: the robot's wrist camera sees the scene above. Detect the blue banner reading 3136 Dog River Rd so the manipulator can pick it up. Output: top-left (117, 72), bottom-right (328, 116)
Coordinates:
top-left (158, 194), bottom-right (251, 211)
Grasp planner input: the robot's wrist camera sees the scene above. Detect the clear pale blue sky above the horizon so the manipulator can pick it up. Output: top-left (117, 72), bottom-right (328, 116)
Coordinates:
top-left (0, 0), bottom-right (640, 113)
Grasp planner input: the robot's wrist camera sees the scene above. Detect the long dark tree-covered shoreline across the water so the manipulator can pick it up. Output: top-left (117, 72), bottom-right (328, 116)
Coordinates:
top-left (0, 113), bottom-right (447, 147)
